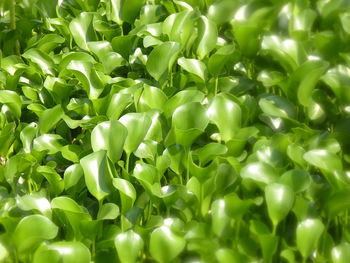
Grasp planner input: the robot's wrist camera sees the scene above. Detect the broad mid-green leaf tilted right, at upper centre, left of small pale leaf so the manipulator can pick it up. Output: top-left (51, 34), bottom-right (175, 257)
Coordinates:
top-left (146, 42), bottom-right (181, 81)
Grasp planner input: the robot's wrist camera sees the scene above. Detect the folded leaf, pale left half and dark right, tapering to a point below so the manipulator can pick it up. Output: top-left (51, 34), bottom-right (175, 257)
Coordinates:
top-left (80, 151), bottom-right (113, 201)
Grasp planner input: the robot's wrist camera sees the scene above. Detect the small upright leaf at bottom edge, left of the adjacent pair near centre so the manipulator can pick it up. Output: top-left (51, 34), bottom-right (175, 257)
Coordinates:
top-left (114, 229), bottom-right (144, 263)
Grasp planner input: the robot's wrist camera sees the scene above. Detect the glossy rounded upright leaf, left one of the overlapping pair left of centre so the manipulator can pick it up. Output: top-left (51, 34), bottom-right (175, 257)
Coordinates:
top-left (91, 120), bottom-right (128, 163)
